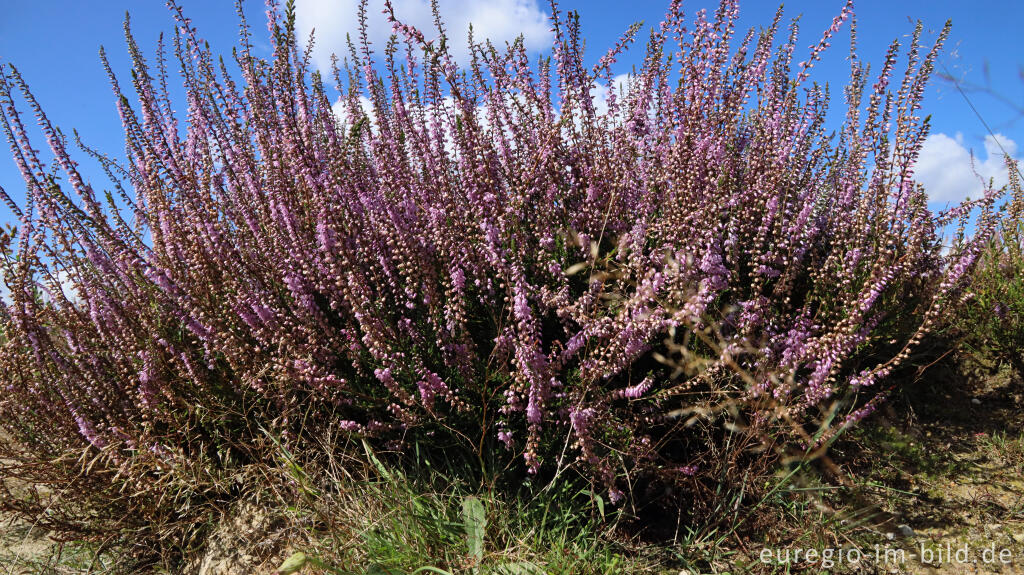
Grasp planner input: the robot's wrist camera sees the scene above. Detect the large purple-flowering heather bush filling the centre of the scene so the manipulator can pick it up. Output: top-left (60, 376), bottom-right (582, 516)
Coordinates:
top-left (0, 0), bottom-right (995, 556)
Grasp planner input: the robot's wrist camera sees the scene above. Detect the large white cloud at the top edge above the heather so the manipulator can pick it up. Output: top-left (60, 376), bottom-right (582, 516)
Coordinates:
top-left (296, 0), bottom-right (552, 71)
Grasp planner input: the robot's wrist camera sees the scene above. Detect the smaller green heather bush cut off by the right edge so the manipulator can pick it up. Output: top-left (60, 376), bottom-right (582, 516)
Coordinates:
top-left (956, 158), bottom-right (1024, 375)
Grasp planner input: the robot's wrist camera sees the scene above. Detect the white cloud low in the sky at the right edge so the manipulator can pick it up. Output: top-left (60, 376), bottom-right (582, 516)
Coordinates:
top-left (914, 132), bottom-right (1019, 203)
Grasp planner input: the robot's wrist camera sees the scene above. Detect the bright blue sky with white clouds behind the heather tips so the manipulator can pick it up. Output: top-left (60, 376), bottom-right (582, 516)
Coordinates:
top-left (0, 0), bottom-right (1024, 223)
